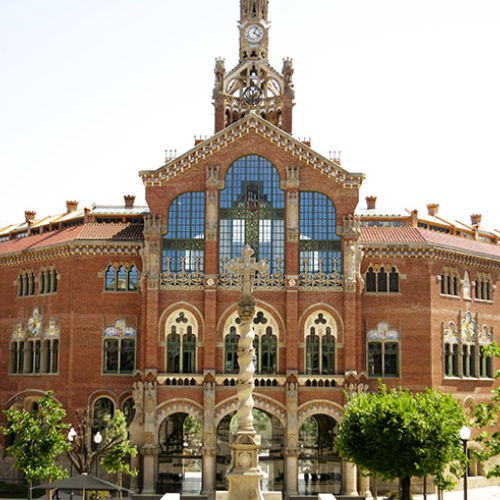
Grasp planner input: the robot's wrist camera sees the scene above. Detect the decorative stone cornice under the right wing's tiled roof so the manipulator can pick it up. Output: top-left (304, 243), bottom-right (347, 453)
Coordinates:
top-left (361, 243), bottom-right (500, 270)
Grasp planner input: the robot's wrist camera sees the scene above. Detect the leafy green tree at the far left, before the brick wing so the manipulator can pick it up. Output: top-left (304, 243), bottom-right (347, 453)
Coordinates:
top-left (1, 391), bottom-right (70, 499)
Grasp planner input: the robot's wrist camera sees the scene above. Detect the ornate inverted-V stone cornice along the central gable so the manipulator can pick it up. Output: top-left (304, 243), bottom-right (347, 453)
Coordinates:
top-left (139, 113), bottom-right (365, 189)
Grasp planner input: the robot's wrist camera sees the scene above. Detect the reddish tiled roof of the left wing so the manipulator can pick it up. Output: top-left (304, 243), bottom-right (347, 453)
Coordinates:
top-left (0, 224), bottom-right (143, 255)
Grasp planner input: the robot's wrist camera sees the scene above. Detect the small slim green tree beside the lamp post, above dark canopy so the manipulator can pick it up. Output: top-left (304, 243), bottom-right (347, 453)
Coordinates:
top-left (100, 410), bottom-right (137, 498)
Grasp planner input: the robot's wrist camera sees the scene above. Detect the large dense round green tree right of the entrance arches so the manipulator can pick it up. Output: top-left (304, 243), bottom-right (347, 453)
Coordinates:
top-left (336, 385), bottom-right (465, 500)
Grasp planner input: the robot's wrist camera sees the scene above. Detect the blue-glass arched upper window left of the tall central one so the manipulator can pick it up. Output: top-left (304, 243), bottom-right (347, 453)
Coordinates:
top-left (162, 192), bottom-right (205, 273)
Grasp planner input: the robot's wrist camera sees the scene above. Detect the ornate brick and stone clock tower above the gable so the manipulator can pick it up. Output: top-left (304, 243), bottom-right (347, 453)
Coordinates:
top-left (213, 0), bottom-right (295, 134)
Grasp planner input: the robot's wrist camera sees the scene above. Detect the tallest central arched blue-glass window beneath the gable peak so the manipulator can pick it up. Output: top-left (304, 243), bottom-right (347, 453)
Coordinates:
top-left (219, 155), bottom-right (285, 273)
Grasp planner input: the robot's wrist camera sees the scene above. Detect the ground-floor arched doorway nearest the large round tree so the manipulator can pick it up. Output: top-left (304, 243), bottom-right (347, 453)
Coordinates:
top-left (299, 414), bottom-right (342, 495)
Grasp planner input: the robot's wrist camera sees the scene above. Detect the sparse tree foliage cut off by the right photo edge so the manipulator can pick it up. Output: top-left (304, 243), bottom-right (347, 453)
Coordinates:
top-left (472, 342), bottom-right (500, 477)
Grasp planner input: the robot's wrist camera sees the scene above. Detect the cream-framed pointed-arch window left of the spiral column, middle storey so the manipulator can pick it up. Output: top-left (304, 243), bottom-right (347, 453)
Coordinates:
top-left (165, 309), bottom-right (198, 373)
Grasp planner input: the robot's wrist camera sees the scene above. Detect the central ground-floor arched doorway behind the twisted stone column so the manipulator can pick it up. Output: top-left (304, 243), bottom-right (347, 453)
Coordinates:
top-left (216, 408), bottom-right (284, 491)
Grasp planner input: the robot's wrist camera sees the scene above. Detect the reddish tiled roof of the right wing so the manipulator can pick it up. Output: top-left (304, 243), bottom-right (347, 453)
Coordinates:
top-left (360, 226), bottom-right (500, 258)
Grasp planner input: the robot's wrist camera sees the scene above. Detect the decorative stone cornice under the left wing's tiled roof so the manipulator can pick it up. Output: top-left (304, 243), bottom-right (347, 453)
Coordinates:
top-left (0, 240), bottom-right (142, 268)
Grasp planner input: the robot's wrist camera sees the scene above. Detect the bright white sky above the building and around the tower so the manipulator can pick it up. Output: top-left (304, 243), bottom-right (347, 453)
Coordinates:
top-left (0, 0), bottom-right (500, 229)
